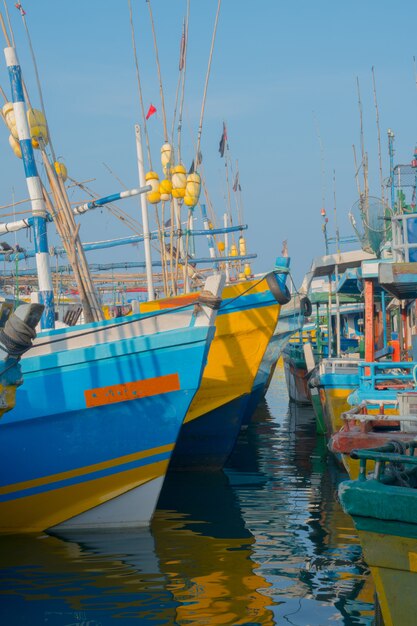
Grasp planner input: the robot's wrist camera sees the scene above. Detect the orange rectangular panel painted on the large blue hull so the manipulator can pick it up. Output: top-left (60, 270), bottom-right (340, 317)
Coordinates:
top-left (84, 374), bottom-right (181, 408)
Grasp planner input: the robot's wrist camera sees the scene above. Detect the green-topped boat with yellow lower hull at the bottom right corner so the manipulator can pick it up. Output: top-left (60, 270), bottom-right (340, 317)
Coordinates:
top-left (339, 441), bottom-right (417, 626)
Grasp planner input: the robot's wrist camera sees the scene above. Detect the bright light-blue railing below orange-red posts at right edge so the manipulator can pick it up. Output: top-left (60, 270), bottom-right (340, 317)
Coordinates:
top-left (358, 361), bottom-right (417, 391)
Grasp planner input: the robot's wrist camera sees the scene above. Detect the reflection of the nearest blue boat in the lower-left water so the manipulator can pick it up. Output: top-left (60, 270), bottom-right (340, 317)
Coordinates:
top-left (0, 529), bottom-right (175, 626)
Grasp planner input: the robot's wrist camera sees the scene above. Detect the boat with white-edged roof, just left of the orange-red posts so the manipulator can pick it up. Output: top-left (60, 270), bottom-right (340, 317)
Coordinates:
top-left (284, 250), bottom-right (374, 408)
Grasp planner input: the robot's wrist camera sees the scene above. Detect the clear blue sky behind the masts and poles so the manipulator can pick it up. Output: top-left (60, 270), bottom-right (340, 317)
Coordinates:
top-left (0, 0), bottom-right (417, 283)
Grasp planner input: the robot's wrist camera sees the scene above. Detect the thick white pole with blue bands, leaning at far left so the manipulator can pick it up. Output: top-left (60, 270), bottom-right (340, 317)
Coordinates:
top-left (4, 47), bottom-right (55, 329)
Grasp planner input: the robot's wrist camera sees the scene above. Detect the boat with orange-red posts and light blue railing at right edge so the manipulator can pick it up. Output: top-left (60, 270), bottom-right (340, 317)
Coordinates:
top-left (330, 176), bottom-right (417, 478)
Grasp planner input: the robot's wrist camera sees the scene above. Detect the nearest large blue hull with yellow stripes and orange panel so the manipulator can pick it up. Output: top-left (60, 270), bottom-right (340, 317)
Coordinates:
top-left (0, 277), bottom-right (222, 532)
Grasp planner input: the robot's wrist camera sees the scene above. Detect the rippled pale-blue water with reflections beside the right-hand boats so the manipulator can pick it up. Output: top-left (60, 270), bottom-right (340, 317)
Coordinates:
top-left (228, 369), bottom-right (374, 626)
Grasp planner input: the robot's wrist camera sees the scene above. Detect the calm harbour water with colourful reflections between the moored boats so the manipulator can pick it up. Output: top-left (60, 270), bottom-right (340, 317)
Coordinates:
top-left (0, 369), bottom-right (374, 626)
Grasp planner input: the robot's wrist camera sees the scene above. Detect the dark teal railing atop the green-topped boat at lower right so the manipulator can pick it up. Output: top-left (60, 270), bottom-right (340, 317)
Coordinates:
top-left (350, 441), bottom-right (417, 482)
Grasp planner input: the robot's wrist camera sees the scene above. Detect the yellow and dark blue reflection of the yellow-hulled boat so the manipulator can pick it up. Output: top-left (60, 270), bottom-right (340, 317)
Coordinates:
top-left (152, 472), bottom-right (275, 626)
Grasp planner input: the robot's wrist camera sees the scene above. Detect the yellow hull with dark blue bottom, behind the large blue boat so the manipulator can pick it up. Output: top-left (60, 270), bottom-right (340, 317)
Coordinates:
top-left (140, 270), bottom-right (285, 470)
